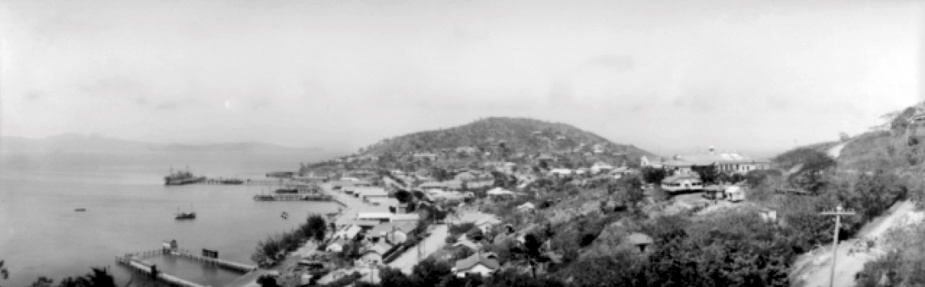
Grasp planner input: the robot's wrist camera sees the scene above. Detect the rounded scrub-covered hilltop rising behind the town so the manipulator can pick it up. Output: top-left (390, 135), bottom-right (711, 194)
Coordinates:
top-left (362, 118), bottom-right (652, 163)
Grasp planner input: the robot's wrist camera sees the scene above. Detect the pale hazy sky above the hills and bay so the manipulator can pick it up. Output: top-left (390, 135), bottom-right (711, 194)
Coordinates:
top-left (0, 0), bottom-right (925, 158)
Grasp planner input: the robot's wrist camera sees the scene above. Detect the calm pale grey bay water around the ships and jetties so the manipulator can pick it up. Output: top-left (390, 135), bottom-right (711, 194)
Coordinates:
top-left (0, 152), bottom-right (338, 287)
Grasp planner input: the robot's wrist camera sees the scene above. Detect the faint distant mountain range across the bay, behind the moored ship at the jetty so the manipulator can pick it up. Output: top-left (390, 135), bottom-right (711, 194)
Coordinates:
top-left (0, 134), bottom-right (322, 153)
